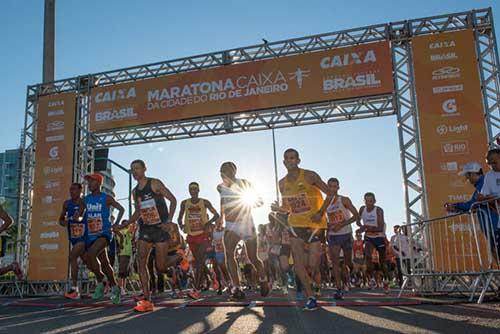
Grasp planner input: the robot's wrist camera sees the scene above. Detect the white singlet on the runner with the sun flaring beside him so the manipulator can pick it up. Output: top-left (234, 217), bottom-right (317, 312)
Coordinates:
top-left (217, 179), bottom-right (253, 224)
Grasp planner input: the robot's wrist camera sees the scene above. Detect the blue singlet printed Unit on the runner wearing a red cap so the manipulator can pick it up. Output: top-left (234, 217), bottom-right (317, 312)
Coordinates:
top-left (85, 193), bottom-right (111, 241)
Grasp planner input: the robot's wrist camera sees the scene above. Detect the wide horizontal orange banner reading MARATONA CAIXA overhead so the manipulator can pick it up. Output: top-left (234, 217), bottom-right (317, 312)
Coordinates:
top-left (90, 42), bottom-right (393, 131)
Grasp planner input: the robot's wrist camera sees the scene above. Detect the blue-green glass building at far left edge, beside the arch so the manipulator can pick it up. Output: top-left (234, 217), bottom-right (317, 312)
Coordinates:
top-left (0, 149), bottom-right (21, 219)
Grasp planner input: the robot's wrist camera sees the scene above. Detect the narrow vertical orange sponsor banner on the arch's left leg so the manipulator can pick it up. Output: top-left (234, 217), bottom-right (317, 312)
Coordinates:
top-left (28, 93), bottom-right (76, 281)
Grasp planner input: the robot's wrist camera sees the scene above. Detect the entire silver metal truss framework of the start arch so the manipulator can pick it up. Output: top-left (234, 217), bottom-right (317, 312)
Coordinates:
top-left (9, 8), bottom-right (500, 294)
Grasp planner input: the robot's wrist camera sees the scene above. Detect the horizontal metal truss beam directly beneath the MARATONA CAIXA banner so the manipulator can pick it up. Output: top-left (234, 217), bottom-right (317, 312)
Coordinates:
top-left (91, 95), bottom-right (394, 148)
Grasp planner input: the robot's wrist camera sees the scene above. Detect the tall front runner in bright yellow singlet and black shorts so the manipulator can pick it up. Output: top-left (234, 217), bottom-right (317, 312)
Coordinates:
top-left (279, 148), bottom-right (329, 310)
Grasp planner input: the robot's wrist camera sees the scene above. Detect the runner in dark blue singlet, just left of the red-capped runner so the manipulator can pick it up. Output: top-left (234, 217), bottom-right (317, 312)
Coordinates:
top-left (59, 183), bottom-right (87, 299)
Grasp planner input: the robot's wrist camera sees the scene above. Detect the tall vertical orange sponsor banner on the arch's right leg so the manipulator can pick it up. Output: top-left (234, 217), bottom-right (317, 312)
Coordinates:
top-left (412, 30), bottom-right (488, 272)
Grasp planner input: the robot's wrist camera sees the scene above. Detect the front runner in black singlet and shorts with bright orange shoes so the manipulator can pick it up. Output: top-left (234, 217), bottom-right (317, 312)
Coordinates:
top-left (113, 160), bottom-right (178, 312)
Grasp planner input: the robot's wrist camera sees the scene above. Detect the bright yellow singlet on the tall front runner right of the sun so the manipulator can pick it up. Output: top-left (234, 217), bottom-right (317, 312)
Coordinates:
top-left (283, 169), bottom-right (326, 229)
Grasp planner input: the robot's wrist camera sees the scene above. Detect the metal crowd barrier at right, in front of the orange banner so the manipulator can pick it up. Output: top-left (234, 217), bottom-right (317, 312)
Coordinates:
top-left (400, 198), bottom-right (500, 303)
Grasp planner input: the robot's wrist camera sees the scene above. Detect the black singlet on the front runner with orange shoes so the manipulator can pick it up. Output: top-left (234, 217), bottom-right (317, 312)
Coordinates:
top-left (134, 178), bottom-right (168, 226)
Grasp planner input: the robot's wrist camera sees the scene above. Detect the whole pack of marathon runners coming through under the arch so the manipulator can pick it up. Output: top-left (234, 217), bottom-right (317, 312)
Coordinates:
top-left (55, 149), bottom-right (394, 312)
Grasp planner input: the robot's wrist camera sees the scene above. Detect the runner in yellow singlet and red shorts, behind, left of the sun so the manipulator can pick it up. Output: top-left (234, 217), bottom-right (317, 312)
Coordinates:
top-left (177, 182), bottom-right (219, 291)
